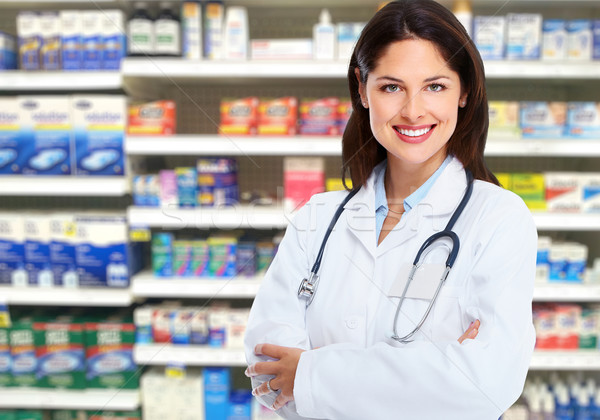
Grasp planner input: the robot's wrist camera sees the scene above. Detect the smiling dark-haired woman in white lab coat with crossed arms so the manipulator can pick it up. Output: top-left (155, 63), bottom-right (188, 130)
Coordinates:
top-left (246, 0), bottom-right (537, 420)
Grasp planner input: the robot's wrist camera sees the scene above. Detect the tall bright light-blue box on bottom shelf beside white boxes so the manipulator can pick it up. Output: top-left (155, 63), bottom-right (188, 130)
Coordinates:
top-left (204, 367), bottom-right (231, 420)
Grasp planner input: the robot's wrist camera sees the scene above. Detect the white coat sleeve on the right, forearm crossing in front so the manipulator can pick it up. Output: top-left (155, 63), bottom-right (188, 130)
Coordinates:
top-left (294, 196), bottom-right (537, 420)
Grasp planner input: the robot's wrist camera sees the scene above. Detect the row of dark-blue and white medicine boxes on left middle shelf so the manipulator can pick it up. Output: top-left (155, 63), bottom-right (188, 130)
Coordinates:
top-left (0, 213), bottom-right (143, 288)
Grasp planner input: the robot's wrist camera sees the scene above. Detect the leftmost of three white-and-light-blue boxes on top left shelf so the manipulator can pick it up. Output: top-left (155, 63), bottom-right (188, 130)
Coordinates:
top-left (59, 10), bottom-right (83, 70)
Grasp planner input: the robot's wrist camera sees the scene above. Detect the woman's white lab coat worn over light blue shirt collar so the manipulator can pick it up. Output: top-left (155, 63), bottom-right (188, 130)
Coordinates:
top-left (245, 158), bottom-right (537, 420)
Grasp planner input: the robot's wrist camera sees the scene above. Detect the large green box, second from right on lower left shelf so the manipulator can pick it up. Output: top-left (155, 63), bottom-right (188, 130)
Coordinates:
top-left (33, 317), bottom-right (85, 389)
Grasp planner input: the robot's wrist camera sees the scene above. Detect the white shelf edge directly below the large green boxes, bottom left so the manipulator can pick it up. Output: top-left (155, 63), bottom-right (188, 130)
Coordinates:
top-left (0, 388), bottom-right (140, 411)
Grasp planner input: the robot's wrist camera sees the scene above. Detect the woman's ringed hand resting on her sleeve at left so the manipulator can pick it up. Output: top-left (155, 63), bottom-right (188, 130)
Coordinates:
top-left (245, 344), bottom-right (305, 410)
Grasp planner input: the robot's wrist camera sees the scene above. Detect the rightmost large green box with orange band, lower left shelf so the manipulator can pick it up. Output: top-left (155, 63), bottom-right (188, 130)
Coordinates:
top-left (85, 320), bottom-right (140, 389)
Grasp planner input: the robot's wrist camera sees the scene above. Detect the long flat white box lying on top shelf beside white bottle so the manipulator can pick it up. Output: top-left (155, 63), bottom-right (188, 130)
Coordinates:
top-left (250, 38), bottom-right (313, 60)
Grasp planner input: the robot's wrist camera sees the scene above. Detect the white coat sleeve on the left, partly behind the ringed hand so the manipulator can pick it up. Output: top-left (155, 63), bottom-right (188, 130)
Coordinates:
top-left (244, 197), bottom-right (322, 419)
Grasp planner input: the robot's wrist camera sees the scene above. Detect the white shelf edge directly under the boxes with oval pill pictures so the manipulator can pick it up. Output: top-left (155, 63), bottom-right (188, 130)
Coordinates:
top-left (0, 175), bottom-right (130, 197)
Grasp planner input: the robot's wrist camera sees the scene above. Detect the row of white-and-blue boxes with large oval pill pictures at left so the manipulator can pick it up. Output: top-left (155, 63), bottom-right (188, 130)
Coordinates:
top-left (0, 95), bottom-right (127, 176)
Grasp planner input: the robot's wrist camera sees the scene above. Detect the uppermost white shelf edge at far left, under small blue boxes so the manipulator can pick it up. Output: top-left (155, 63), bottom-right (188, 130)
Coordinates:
top-left (0, 70), bottom-right (122, 92)
